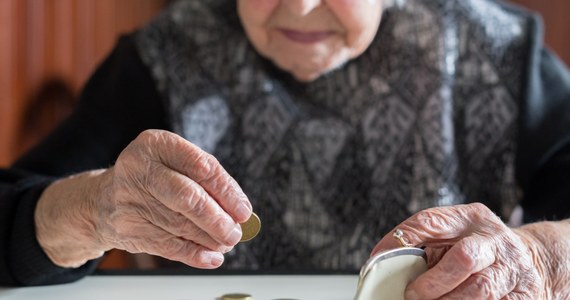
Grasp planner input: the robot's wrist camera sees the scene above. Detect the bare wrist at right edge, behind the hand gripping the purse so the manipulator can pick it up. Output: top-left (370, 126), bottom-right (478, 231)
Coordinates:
top-left (516, 219), bottom-right (570, 299)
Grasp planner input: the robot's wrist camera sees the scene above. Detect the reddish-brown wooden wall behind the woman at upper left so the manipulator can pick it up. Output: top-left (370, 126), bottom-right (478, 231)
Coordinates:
top-left (0, 0), bottom-right (167, 167)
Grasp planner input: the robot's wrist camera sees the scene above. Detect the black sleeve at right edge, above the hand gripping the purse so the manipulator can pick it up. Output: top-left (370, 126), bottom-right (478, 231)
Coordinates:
top-left (518, 46), bottom-right (570, 222)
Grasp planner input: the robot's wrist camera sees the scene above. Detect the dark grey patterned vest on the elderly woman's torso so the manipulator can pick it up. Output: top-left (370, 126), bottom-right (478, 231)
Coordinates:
top-left (136, 0), bottom-right (532, 270)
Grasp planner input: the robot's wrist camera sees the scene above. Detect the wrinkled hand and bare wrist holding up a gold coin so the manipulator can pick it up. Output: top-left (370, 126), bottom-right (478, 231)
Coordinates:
top-left (35, 130), bottom-right (252, 268)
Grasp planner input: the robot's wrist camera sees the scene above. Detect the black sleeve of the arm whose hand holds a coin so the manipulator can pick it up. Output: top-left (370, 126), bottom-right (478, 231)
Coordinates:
top-left (0, 37), bottom-right (170, 286)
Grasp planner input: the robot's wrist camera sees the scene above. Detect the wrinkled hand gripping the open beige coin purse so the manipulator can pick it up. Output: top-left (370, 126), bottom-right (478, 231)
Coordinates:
top-left (372, 203), bottom-right (547, 300)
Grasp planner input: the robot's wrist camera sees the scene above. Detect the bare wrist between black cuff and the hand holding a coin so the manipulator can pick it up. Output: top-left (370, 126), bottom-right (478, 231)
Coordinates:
top-left (34, 170), bottom-right (109, 267)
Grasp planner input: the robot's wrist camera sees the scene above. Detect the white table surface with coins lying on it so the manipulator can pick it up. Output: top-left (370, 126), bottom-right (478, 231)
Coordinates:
top-left (0, 275), bottom-right (358, 300)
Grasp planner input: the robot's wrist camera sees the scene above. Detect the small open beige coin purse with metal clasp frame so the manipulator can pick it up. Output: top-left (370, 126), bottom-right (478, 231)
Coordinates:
top-left (354, 231), bottom-right (428, 300)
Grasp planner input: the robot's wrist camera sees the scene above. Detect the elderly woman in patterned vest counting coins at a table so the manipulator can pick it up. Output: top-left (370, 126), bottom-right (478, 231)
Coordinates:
top-left (0, 0), bottom-right (570, 299)
